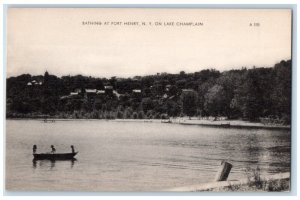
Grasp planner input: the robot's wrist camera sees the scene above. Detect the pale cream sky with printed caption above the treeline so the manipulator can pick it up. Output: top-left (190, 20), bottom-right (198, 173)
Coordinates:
top-left (6, 8), bottom-right (291, 78)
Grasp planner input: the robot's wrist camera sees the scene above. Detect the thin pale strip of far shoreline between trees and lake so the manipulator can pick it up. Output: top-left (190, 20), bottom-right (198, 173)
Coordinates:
top-left (7, 117), bottom-right (291, 130)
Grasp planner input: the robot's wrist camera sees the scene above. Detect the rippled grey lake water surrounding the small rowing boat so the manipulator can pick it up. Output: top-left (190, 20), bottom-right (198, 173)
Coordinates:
top-left (5, 120), bottom-right (291, 191)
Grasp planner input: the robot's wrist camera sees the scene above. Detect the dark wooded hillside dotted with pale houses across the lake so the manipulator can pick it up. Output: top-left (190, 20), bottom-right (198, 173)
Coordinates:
top-left (6, 60), bottom-right (291, 123)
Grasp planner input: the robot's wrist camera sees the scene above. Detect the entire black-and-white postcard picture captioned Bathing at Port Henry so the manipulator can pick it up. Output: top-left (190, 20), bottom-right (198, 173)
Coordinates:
top-left (4, 7), bottom-right (293, 193)
